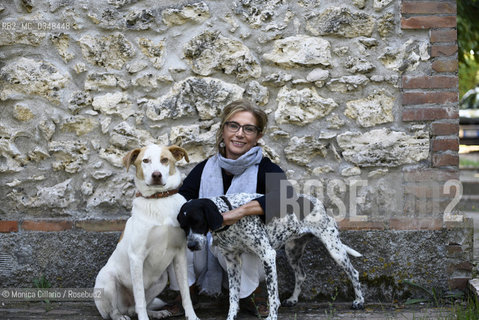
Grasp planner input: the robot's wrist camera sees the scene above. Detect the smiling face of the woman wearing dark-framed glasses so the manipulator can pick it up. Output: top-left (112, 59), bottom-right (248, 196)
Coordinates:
top-left (223, 111), bottom-right (263, 159)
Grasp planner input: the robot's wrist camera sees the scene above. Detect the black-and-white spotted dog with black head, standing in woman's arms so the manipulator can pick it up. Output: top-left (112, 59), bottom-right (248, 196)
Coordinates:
top-left (178, 193), bottom-right (364, 320)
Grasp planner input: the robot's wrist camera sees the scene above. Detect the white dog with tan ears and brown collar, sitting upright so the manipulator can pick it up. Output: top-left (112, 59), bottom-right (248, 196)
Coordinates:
top-left (95, 145), bottom-right (198, 320)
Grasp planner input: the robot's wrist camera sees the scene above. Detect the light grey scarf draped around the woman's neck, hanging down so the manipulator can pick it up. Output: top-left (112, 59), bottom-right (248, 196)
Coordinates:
top-left (198, 147), bottom-right (263, 296)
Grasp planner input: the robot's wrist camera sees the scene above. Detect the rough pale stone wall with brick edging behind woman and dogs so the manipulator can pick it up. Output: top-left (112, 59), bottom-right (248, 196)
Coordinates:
top-left (0, 0), bottom-right (471, 298)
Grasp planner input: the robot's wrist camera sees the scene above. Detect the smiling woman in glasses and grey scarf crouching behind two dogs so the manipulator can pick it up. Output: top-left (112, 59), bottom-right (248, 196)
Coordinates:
top-left (170, 100), bottom-right (286, 316)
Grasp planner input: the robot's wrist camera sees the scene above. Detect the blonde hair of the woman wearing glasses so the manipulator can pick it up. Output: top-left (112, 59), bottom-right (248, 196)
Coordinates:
top-left (216, 100), bottom-right (268, 156)
